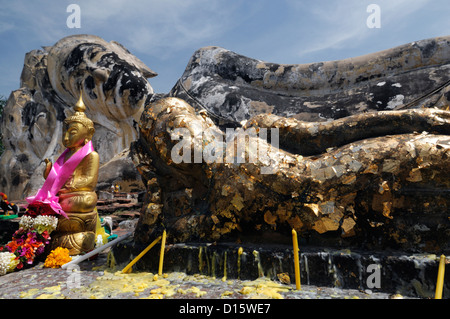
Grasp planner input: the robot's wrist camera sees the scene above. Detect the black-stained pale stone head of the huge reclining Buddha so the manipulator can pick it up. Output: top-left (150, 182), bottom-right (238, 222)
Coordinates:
top-left (46, 34), bottom-right (157, 121)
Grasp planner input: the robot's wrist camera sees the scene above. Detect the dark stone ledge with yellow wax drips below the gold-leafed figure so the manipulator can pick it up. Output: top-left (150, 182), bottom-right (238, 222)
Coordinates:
top-left (112, 239), bottom-right (450, 298)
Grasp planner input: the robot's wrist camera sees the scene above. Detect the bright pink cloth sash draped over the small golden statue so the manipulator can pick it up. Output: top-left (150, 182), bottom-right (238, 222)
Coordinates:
top-left (27, 141), bottom-right (94, 218)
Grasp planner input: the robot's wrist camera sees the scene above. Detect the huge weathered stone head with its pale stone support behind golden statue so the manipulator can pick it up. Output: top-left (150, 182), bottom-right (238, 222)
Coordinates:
top-left (0, 35), bottom-right (156, 199)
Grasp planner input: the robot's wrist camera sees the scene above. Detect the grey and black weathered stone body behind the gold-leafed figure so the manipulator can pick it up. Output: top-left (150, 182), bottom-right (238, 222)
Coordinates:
top-left (171, 37), bottom-right (450, 124)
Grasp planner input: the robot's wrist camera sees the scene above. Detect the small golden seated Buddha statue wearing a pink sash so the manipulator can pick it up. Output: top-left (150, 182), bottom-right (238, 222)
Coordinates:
top-left (44, 95), bottom-right (99, 255)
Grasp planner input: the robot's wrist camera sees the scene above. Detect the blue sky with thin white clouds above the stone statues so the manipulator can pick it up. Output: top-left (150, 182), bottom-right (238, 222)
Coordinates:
top-left (0, 0), bottom-right (450, 97)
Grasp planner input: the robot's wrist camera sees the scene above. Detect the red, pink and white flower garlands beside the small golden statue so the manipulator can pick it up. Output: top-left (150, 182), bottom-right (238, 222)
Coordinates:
top-left (0, 202), bottom-right (58, 275)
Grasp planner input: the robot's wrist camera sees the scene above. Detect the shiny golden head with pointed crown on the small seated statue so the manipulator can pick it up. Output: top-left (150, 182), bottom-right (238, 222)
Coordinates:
top-left (62, 94), bottom-right (95, 149)
